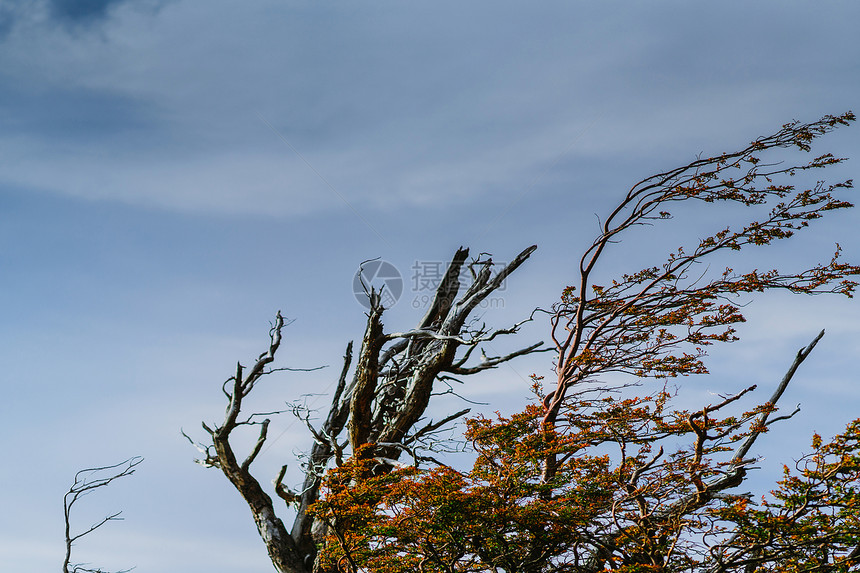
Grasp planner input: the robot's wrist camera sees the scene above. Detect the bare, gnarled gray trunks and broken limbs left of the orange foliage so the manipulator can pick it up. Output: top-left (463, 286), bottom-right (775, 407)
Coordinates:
top-left (186, 246), bottom-right (542, 573)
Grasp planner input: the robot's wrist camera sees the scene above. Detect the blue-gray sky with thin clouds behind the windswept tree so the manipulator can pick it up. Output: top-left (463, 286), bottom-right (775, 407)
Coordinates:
top-left (0, 0), bottom-right (860, 573)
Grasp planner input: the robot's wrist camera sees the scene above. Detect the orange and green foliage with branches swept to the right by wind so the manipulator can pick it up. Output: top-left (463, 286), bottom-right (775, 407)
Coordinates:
top-left (313, 113), bottom-right (860, 573)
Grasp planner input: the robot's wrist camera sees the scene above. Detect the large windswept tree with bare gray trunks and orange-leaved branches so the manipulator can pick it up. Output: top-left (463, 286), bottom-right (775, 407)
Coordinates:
top-left (188, 113), bottom-right (860, 573)
